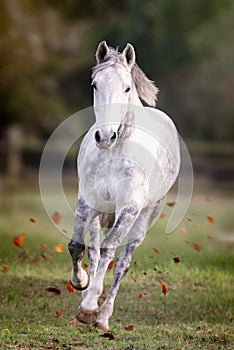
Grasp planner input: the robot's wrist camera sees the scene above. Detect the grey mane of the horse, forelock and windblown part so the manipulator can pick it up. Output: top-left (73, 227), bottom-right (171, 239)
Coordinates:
top-left (92, 48), bottom-right (158, 107)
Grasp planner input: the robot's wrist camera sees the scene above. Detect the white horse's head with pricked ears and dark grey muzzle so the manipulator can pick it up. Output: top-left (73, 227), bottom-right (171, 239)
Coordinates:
top-left (92, 41), bottom-right (136, 148)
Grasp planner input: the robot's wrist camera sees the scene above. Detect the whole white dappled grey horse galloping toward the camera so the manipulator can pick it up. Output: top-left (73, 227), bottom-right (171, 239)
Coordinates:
top-left (68, 41), bottom-right (180, 330)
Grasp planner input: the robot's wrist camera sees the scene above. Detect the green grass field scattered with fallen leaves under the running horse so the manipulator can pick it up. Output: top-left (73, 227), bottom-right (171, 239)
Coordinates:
top-left (0, 182), bottom-right (234, 350)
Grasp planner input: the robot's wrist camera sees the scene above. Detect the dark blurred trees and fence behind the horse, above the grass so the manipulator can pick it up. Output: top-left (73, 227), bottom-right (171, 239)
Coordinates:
top-left (0, 0), bottom-right (234, 198)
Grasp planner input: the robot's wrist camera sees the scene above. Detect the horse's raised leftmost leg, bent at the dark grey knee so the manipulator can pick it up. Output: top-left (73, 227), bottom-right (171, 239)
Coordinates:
top-left (68, 196), bottom-right (97, 290)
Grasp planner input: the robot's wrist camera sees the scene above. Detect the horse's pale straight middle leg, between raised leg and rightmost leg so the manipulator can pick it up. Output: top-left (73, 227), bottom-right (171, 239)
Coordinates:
top-left (77, 202), bottom-right (140, 323)
